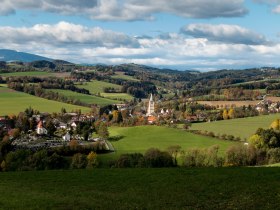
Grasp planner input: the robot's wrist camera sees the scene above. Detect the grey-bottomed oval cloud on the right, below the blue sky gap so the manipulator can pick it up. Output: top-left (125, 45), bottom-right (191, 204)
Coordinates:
top-left (181, 24), bottom-right (268, 45)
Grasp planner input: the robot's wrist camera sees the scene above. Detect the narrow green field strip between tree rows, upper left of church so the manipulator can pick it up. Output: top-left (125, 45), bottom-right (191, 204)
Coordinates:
top-left (49, 89), bottom-right (120, 106)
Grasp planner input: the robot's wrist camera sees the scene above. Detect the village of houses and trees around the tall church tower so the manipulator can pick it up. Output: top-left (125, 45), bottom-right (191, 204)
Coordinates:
top-left (0, 94), bottom-right (279, 151)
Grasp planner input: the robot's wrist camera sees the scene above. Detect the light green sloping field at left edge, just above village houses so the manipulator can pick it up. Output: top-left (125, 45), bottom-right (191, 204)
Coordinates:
top-left (0, 87), bottom-right (90, 115)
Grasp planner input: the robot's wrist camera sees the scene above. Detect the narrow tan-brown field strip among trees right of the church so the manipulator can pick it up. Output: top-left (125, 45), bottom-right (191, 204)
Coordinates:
top-left (197, 100), bottom-right (260, 108)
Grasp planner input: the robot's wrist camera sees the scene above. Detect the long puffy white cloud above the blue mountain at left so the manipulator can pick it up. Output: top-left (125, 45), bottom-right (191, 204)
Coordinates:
top-left (0, 22), bottom-right (139, 47)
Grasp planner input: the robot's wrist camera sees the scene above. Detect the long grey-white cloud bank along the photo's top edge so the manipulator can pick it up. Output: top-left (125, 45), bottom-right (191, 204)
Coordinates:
top-left (0, 0), bottom-right (248, 21)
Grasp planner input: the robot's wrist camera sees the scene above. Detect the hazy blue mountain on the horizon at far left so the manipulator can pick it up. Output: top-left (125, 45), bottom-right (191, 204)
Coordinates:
top-left (0, 49), bottom-right (53, 62)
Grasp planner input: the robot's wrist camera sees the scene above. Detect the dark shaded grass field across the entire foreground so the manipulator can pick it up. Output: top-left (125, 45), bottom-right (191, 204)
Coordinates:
top-left (0, 168), bottom-right (280, 210)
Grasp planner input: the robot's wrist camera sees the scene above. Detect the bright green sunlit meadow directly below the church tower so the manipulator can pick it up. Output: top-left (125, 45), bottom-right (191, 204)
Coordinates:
top-left (100, 126), bottom-right (238, 162)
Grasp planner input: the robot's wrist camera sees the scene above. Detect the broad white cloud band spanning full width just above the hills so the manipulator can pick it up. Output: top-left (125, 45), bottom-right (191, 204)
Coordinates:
top-left (0, 22), bottom-right (280, 69)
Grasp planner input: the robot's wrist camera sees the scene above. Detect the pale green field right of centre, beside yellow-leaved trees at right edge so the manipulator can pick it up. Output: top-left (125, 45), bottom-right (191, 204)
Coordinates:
top-left (191, 114), bottom-right (280, 139)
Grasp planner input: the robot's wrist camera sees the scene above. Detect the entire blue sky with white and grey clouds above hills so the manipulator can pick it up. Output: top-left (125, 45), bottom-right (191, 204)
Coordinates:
top-left (0, 0), bottom-right (280, 71)
